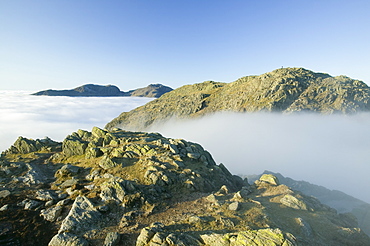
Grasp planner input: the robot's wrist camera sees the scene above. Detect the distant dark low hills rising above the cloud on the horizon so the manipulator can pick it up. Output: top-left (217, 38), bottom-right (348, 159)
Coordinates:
top-left (32, 84), bottom-right (172, 97)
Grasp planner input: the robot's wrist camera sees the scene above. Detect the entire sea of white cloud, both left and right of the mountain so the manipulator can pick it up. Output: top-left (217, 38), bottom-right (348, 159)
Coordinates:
top-left (0, 91), bottom-right (370, 202)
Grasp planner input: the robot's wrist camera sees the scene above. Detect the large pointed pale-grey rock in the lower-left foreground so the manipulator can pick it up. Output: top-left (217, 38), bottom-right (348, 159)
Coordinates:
top-left (59, 196), bottom-right (102, 233)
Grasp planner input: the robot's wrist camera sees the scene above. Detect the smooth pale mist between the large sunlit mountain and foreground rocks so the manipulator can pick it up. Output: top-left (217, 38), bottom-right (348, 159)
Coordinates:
top-left (151, 113), bottom-right (370, 202)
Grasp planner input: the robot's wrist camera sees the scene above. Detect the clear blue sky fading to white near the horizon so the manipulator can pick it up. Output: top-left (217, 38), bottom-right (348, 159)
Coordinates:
top-left (0, 0), bottom-right (370, 91)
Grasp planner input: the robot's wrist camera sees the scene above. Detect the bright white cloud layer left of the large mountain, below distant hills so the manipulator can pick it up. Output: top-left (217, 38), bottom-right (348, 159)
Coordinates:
top-left (0, 91), bottom-right (153, 151)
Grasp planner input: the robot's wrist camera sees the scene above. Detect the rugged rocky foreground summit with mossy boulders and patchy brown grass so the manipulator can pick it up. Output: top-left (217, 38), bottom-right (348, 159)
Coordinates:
top-left (0, 127), bottom-right (370, 246)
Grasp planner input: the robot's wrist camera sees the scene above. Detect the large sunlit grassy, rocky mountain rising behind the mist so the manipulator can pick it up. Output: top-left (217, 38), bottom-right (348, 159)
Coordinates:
top-left (106, 68), bottom-right (370, 130)
